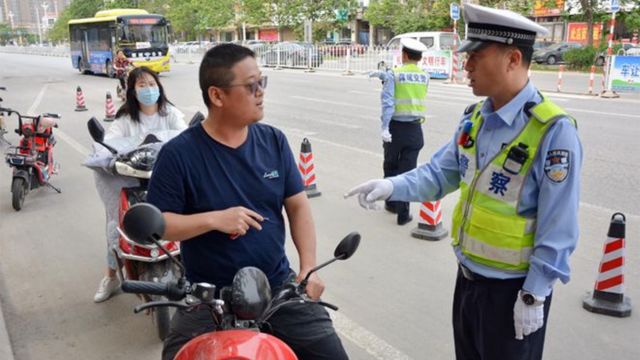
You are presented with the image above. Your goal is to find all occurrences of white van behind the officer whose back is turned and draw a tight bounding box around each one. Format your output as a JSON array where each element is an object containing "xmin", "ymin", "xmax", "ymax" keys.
[{"xmin": 378, "ymin": 31, "xmax": 454, "ymax": 79}]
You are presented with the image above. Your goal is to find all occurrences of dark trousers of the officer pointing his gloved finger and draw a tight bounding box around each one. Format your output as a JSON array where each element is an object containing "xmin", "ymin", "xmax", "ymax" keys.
[{"xmin": 453, "ymin": 270, "xmax": 551, "ymax": 360}]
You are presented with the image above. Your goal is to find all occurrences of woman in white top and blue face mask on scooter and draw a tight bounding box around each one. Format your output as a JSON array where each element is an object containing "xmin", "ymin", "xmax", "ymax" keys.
[{"xmin": 93, "ymin": 67, "xmax": 187, "ymax": 302}]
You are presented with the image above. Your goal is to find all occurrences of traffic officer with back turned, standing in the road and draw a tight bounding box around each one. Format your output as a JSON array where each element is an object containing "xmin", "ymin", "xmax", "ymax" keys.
[{"xmin": 370, "ymin": 38, "xmax": 429, "ymax": 225}]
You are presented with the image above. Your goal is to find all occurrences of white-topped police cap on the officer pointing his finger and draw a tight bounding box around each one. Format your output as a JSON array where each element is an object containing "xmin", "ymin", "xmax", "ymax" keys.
[{"xmin": 458, "ymin": 4, "xmax": 549, "ymax": 52}]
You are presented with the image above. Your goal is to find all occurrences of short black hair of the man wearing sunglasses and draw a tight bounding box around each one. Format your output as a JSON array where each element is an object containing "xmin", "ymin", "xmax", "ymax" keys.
[{"xmin": 200, "ymin": 44, "xmax": 256, "ymax": 108}]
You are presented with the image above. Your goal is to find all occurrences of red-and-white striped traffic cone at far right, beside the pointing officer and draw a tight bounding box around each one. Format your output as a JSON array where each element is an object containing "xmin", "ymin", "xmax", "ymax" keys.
[{"xmin": 582, "ymin": 213, "xmax": 631, "ymax": 317}]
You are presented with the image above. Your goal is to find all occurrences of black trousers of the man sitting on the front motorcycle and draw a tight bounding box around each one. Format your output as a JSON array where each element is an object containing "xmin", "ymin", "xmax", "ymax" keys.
[{"xmin": 162, "ymin": 276, "xmax": 349, "ymax": 360}]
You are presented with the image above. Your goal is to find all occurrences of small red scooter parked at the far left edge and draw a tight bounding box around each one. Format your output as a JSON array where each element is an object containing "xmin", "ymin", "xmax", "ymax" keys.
[{"xmin": 0, "ymin": 95, "xmax": 62, "ymax": 211}]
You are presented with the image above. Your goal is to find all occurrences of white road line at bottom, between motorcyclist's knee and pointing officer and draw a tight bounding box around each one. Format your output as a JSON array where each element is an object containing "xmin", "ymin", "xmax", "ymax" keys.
[{"xmin": 331, "ymin": 311, "xmax": 411, "ymax": 360}]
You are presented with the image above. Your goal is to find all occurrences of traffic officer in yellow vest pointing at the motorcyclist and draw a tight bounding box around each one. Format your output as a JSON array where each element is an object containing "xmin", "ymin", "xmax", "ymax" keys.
[{"xmin": 345, "ymin": 4, "xmax": 582, "ymax": 360}]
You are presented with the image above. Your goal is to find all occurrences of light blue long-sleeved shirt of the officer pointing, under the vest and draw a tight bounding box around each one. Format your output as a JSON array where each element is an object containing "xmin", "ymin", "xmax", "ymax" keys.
[{"xmin": 390, "ymin": 82, "xmax": 582, "ymax": 296}]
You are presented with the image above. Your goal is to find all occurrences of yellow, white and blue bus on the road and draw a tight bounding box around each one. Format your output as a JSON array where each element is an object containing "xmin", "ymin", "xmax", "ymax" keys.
[{"xmin": 69, "ymin": 9, "xmax": 170, "ymax": 76}]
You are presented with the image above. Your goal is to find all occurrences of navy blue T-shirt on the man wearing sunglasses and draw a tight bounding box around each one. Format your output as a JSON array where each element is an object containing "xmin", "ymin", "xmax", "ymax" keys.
[{"xmin": 147, "ymin": 124, "xmax": 304, "ymax": 287}]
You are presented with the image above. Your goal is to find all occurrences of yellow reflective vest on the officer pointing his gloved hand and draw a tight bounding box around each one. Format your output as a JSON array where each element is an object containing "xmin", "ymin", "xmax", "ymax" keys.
[{"xmin": 451, "ymin": 98, "xmax": 576, "ymax": 273}]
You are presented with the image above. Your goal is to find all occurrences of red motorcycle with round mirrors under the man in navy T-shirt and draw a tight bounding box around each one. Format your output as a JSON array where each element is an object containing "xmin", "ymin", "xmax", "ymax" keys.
[{"xmin": 122, "ymin": 204, "xmax": 360, "ymax": 360}]
